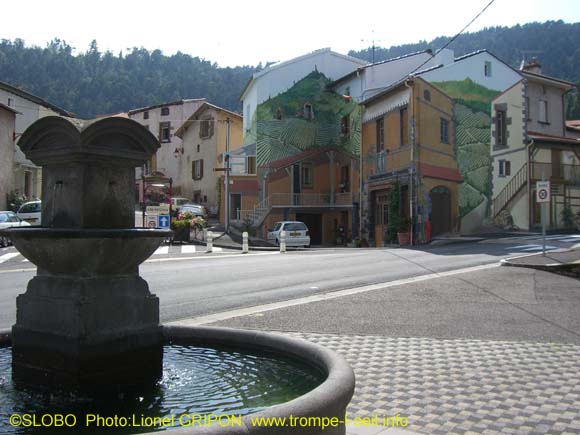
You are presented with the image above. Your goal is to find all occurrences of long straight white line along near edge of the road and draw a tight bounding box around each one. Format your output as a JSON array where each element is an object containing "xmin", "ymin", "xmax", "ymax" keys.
[{"xmin": 169, "ymin": 263, "xmax": 500, "ymax": 326}]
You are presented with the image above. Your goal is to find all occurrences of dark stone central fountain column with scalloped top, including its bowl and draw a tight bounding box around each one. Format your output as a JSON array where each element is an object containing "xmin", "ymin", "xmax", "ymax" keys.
[{"xmin": 10, "ymin": 117, "xmax": 169, "ymax": 388}]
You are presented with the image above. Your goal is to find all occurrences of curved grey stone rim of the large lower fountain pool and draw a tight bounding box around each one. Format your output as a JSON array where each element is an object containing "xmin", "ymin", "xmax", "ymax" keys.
[{"xmin": 0, "ymin": 326, "xmax": 354, "ymax": 435}]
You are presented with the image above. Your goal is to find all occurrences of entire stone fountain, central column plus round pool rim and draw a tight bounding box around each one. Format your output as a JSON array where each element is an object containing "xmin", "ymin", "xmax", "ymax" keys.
[{"xmin": 0, "ymin": 117, "xmax": 354, "ymax": 435}]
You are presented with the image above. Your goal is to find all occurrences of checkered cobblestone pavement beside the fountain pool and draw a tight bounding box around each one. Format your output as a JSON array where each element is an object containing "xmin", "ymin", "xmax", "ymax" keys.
[{"xmin": 290, "ymin": 333, "xmax": 580, "ymax": 434}]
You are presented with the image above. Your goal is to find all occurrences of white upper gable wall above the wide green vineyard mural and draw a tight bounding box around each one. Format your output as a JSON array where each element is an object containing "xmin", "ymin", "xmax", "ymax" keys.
[{"xmin": 240, "ymin": 48, "xmax": 368, "ymax": 130}]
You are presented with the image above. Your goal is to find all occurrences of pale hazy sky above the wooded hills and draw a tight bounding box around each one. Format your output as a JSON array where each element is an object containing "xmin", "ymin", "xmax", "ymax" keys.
[{"xmin": 0, "ymin": 0, "xmax": 580, "ymax": 67}]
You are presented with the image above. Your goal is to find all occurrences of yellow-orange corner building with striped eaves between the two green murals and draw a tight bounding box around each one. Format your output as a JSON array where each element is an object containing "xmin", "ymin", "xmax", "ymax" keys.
[{"xmin": 361, "ymin": 77, "xmax": 462, "ymax": 246}]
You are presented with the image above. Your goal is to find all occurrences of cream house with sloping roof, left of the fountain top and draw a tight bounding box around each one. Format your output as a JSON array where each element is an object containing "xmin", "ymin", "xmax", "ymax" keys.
[{"xmin": 0, "ymin": 82, "xmax": 74, "ymax": 199}]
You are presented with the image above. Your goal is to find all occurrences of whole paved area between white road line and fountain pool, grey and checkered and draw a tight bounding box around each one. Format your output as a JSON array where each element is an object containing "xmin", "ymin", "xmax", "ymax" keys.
[{"xmin": 208, "ymin": 268, "xmax": 580, "ymax": 435}]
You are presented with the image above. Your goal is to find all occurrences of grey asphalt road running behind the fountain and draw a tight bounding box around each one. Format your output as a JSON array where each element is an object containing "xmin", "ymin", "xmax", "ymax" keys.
[{"xmin": 0, "ymin": 238, "xmax": 580, "ymax": 328}]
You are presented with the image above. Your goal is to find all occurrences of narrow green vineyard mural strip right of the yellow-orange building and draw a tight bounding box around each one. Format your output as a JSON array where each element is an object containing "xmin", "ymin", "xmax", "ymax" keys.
[{"xmin": 434, "ymin": 79, "xmax": 499, "ymax": 225}]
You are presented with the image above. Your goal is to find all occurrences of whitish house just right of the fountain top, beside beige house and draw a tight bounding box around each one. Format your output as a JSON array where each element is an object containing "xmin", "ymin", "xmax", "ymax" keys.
[{"xmin": 128, "ymin": 98, "xmax": 205, "ymax": 195}]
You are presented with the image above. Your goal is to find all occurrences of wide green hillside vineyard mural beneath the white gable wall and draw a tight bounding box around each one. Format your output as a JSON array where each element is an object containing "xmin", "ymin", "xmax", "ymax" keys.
[{"xmin": 245, "ymin": 71, "xmax": 361, "ymax": 166}]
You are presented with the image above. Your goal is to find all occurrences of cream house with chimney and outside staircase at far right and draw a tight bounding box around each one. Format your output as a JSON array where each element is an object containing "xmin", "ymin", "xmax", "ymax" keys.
[{"xmin": 491, "ymin": 60, "xmax": 580, "ymax": 230}]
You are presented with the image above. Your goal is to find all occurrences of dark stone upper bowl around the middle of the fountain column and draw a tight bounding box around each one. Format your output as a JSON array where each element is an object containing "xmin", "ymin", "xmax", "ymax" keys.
[{"xmin": 5, "ymin": 227, "xmax": 171, "ymax": 276}]
